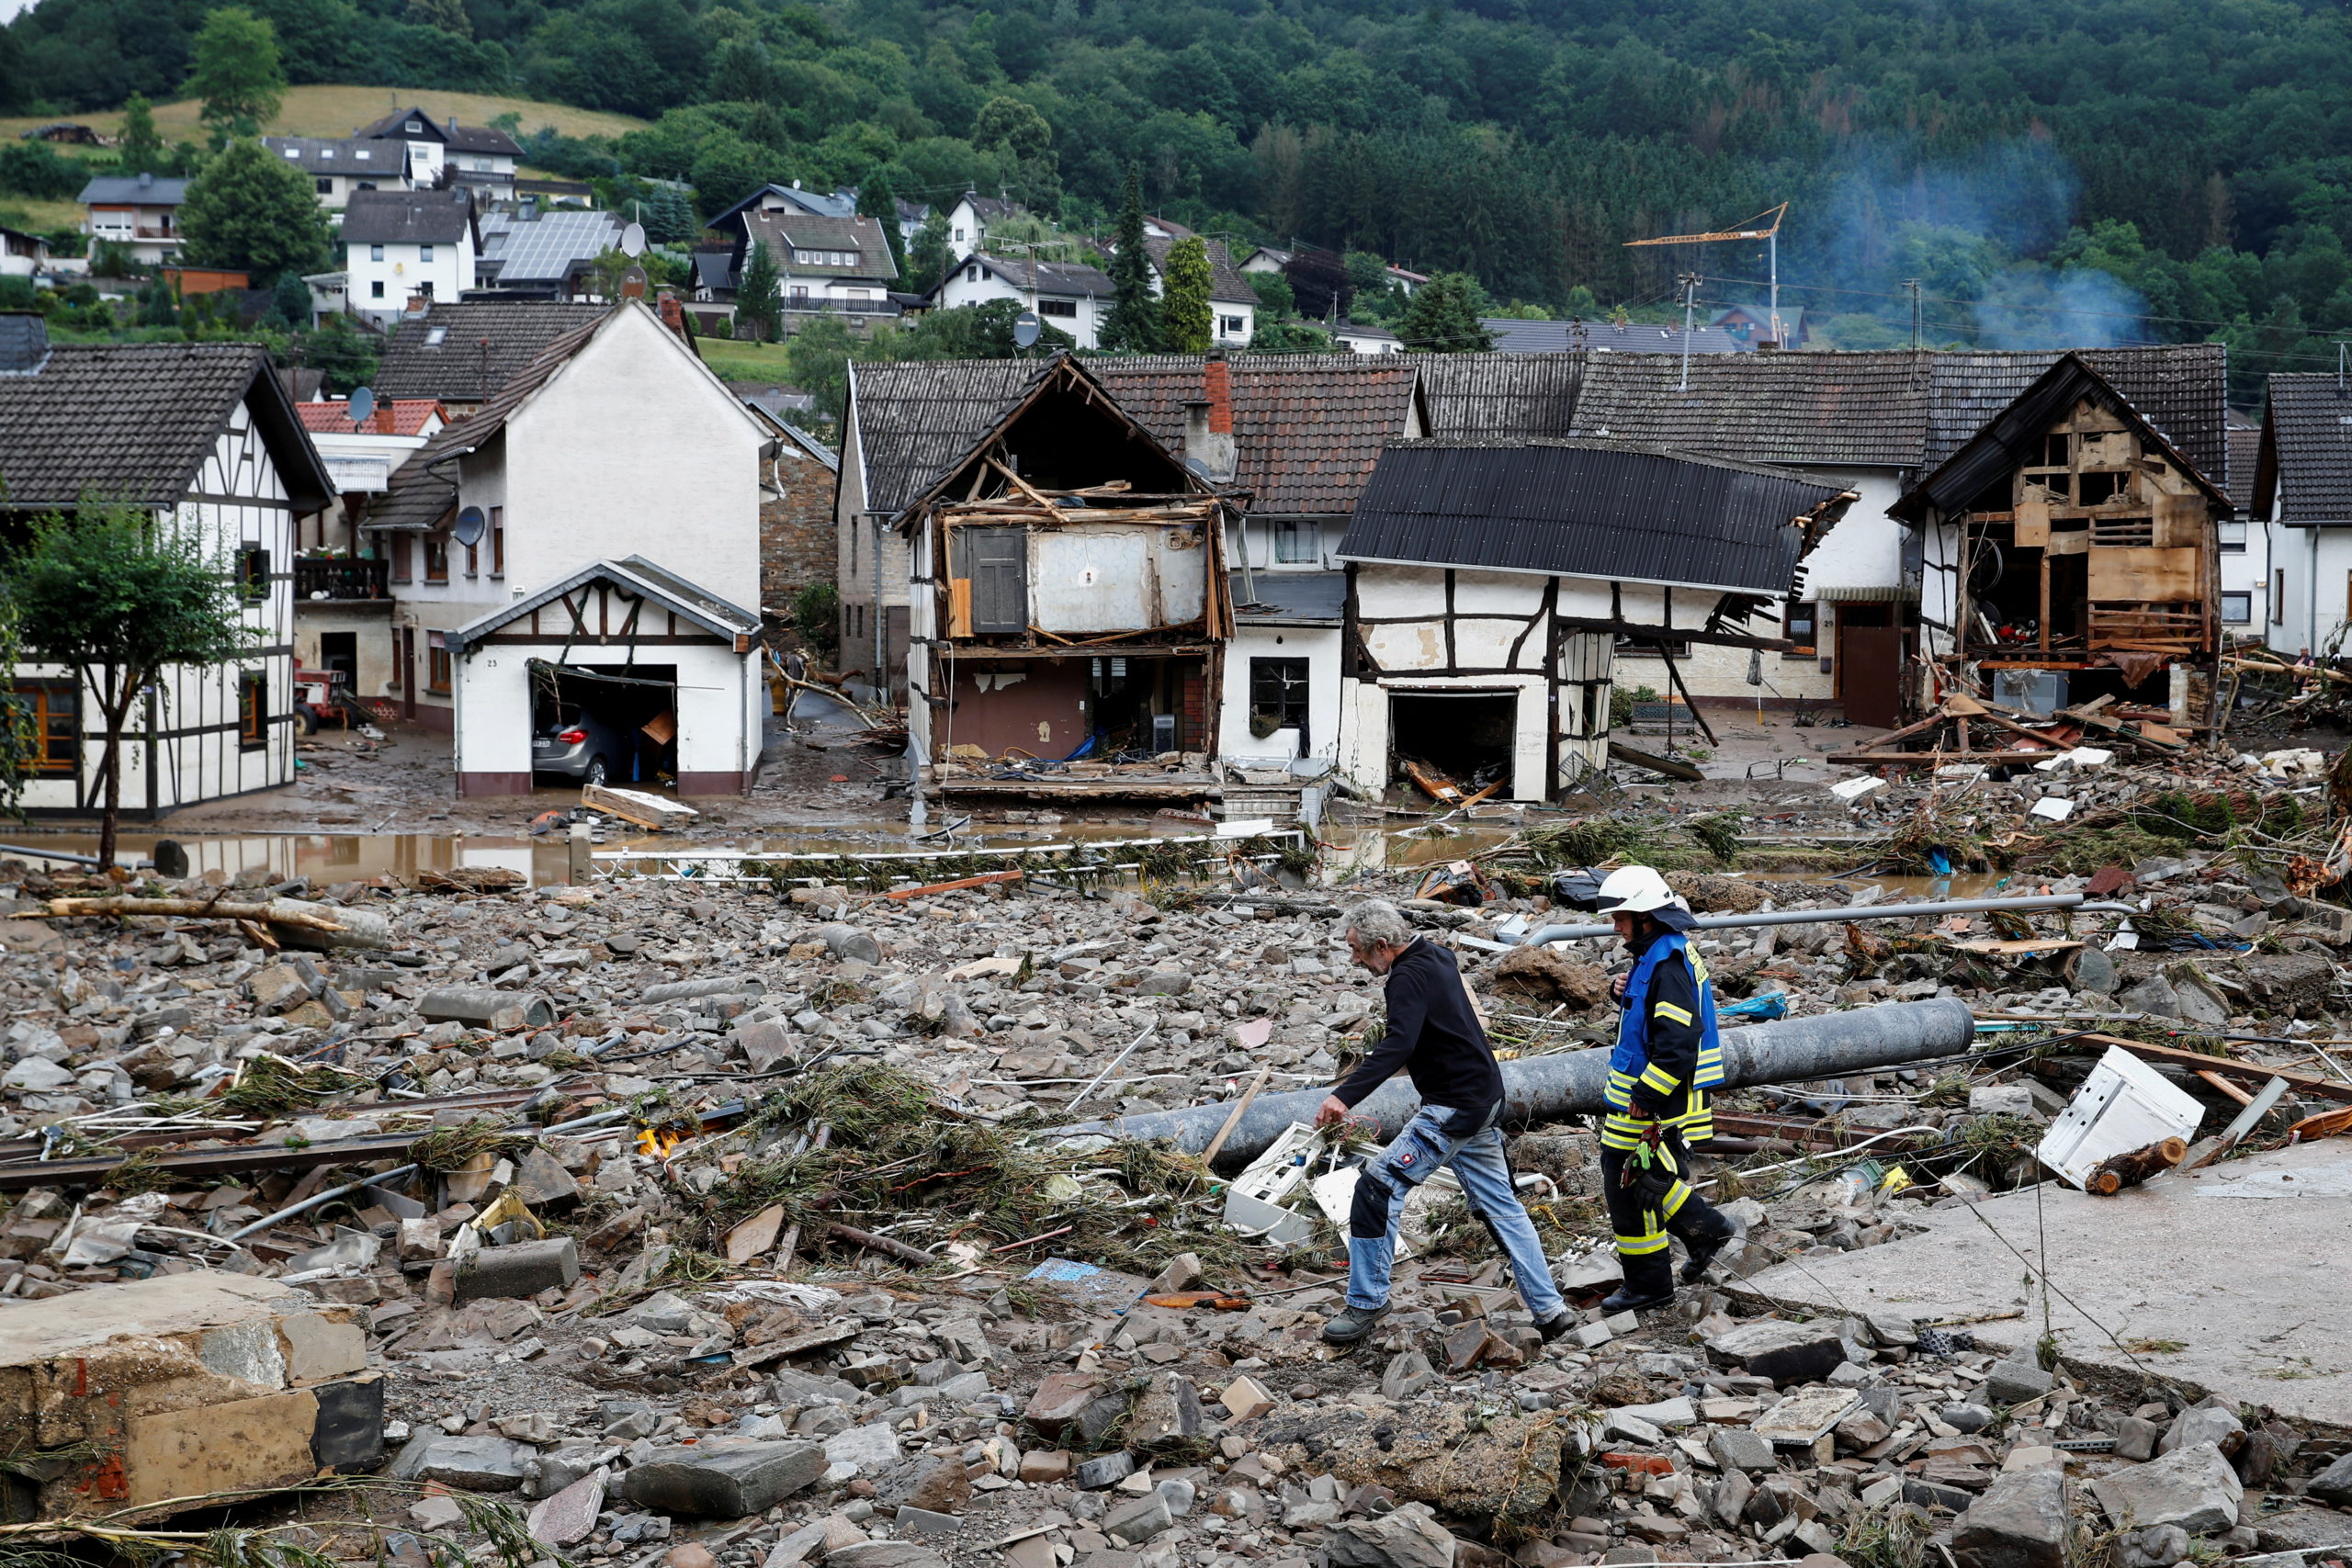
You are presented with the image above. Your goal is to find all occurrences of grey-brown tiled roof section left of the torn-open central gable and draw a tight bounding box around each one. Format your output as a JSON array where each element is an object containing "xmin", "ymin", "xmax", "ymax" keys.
[{"xmin": 849, "ymin": 360, "xmax": 1054, "ymax": 513}]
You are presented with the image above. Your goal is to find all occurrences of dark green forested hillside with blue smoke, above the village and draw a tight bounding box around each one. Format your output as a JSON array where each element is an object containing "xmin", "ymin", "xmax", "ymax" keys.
[{"xmin": 0, "ymin": 0, "xmax": 2352, "ymax": 380}]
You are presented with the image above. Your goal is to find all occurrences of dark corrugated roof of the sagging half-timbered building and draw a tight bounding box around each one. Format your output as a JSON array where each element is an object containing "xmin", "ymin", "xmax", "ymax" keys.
[{"xmin": 1339, "ymin": 440, "xmax": 1847, "ymax": 597}]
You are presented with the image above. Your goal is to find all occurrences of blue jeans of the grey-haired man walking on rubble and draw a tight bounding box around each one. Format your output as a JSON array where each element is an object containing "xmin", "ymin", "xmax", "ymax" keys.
[{"xmin": 1348, "ymin": 1100, "xmax": 1566, "ymax": 1319}]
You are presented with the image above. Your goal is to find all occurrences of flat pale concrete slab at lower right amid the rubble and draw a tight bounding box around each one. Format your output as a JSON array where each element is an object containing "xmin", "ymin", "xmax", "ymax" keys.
[{"xmin": 1734, "ymin": 1138, "xmax": 2352, "ymax": 1427}]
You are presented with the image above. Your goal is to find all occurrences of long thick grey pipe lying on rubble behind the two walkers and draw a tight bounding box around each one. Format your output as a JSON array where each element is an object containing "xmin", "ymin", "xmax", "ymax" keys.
[{"xmin": 1049, "ymin": 997, "xmax": 1975, "ymax": 1170}]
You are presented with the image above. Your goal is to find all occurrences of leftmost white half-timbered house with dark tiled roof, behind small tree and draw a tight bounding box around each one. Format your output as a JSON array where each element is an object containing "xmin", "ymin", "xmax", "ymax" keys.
[{"xmin": 0, "ymin": 331, "xmax": 332, "ymax": 816}]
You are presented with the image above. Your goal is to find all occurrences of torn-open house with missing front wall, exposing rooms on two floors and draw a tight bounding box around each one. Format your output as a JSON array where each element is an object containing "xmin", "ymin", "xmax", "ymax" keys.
[{"xmin": 896, "ymin": 355, "xmax": 1232, "ymax": 799}]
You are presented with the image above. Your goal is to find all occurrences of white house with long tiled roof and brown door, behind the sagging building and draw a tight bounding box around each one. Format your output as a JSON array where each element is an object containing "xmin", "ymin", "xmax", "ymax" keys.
[{"xmin": 1561, "ymin": 344, "xmax": 2230, "ymax": 724}]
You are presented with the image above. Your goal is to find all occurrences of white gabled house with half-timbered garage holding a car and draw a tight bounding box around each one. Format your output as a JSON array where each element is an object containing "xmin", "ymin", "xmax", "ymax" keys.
[{"xmin": 362, "ymin": 301, "xmax": 772, "ymax": 795}]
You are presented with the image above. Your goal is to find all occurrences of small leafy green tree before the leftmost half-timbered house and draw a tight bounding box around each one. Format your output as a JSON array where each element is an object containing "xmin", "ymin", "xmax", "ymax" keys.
[{"xmin": 5, "ymin": 505, "xmax": 254, "ymax": 865}]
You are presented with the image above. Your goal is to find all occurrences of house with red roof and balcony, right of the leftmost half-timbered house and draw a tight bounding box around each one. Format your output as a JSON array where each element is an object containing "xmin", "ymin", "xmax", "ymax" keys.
[{"xmin": 291, "ymin": 398, "xmax": 449, "ymax": 694}]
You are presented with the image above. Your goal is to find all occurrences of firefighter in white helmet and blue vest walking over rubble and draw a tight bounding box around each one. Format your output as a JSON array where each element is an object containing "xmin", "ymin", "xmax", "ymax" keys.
[{"xmin": 1600, "ymin": 865, "xmax": 1734, "ymax": 1312}]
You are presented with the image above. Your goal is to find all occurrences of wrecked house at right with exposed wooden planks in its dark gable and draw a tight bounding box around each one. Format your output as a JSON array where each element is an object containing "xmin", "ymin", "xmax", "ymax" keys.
[{"xmin": 1891, "ymin": 355, "xmax": 2232, "ymax": 724}]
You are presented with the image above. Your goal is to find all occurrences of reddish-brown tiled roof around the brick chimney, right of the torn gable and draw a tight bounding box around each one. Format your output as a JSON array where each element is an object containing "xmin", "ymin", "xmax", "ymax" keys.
[{"xmin": 1087, "ymin": 355, "xmax": 1419, "ymax": 517}]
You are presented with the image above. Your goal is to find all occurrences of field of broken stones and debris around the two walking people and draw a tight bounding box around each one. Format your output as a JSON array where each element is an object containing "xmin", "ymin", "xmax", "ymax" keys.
[{"xmin": 0, "ymin": 752, "xmax": 2352, "ymax": 1568}]
